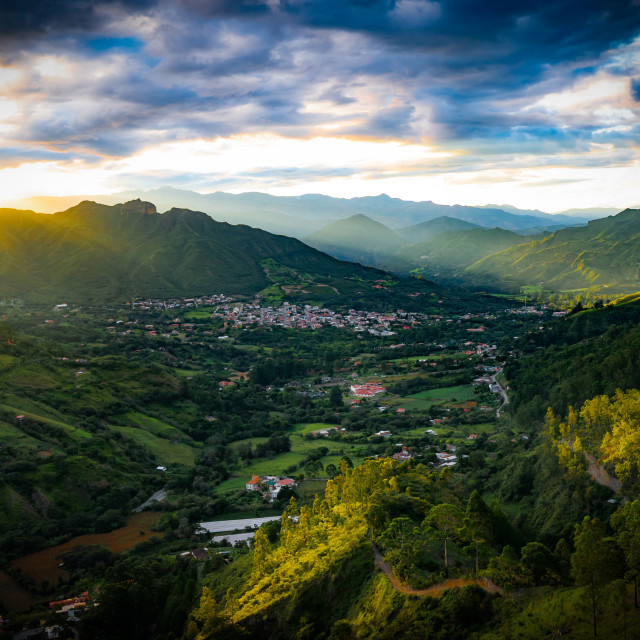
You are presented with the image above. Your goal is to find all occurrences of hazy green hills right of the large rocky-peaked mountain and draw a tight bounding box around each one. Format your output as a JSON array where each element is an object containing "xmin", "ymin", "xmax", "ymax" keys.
[{"xmin": 305, "ymin": 209, "xmax": 640, "ymax": 292}]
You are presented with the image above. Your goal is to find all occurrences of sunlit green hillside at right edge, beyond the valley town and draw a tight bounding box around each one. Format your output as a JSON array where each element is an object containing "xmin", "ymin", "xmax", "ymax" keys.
[{"xmin": 466, "ymin": 209, "xmax": 640, "ymax": 290}]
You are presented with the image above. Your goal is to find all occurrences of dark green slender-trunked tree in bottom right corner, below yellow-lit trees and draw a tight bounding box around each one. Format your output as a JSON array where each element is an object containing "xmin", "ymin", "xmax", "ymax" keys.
[{"xmin": 571, "ymin": 516, "xmax": 621, "ymax": 636}]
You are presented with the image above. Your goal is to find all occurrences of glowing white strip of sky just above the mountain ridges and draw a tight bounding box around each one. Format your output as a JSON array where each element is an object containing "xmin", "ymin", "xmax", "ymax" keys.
[{"xmin": 0, "ymin": 134, "xmax": 640, "ymax": 212}]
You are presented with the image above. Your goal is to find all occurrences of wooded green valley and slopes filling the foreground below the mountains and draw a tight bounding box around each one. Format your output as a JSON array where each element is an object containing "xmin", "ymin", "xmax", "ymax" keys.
[{"xmin": 0, "ymin": 298, "xmax": 640, "ymax": 640}]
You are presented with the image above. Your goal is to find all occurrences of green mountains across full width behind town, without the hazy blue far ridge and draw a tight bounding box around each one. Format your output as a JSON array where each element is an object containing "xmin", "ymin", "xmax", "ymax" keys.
[{"xmin": 0, "ymin": 196, "xmax": 640, "ymax": 303}]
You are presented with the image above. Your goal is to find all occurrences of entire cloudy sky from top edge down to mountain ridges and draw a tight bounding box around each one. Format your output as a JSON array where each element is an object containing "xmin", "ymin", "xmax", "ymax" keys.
[{"xmin": 0, "ymin": 0, "xmax": 640, "ymax": 211}]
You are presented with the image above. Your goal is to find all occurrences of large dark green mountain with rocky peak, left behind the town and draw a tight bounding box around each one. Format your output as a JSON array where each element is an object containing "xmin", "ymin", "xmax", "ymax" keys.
[{"xmin": 0, "ymin": 201, "xmax": 388, "ymax": 302}]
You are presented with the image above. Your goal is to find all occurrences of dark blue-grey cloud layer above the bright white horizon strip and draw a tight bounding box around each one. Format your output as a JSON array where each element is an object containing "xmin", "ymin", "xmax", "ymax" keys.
[{"xmin": 0, "ymin": 0, "xmax": 640, "ymax": 165}]
